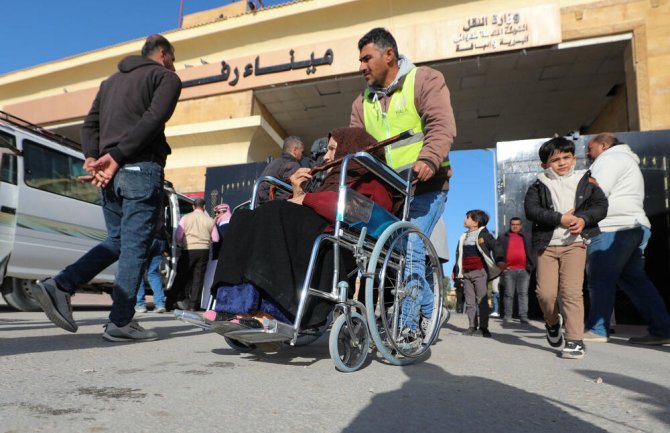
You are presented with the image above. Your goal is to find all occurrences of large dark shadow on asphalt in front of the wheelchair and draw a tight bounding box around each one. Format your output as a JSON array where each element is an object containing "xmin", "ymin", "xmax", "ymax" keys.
[{"xmin": 343, "ymin": 363, "xmax": 616, "ymax": 433}]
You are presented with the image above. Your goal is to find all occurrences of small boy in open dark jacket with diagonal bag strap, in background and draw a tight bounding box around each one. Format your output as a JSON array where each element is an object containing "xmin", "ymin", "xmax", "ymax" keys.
[{"xmin": 454, "ymin": 209, "xmax": 500, "ymax": 337}]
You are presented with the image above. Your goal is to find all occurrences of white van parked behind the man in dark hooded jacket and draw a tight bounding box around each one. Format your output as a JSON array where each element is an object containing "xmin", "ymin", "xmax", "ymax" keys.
[{"xmin": 0, "ymin": 111, "xmax": 192, "ymax": 311}]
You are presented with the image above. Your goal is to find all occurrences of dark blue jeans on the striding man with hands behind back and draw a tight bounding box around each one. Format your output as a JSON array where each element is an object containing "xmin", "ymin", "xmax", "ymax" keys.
[{"xmin": 54, "ymin": 162, "xmax": 163, "ymax": 326}]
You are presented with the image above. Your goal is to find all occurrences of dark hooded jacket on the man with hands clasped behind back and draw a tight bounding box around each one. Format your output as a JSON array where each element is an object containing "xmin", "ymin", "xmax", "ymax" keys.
[{"xmin": 81, "ymin": 56, "xmax": 181, "ymax": 166}]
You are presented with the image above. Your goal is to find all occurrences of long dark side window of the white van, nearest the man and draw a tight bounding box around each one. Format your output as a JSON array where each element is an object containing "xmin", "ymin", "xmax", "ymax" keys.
[{"xmin": 23, "ymin": 140, "xmax": 100, "ymax": 205}]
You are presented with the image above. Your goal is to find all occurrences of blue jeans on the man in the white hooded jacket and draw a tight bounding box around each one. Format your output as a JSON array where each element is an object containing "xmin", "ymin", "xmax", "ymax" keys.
[{"xmin": 586, "ymin": 226, "xmax": 670, "ymax": 337}]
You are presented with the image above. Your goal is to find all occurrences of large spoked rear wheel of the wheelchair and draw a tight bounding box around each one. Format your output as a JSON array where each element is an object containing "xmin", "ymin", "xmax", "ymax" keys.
[{"xmin": 365, "ymin": 221, "xmax": 443, "ymax": 365}]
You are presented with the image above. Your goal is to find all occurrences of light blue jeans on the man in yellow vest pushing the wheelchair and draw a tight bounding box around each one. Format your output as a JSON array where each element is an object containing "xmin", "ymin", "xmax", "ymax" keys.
[{"xmin": 400, "ymin": 191, "xmax": 447, "ymax": 331}]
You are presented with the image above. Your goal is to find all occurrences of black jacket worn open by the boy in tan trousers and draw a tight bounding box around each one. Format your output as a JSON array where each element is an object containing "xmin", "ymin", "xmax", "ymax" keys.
[{"xmin": 524, "ymin": 171, "xmax": 607, "ymax": 253}]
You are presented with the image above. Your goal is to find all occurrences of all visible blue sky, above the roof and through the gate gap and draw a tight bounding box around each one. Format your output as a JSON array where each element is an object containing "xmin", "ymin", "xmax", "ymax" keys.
[{"xmin": 0, "ymin": 0, "xmax": 495, "ymax": 275}]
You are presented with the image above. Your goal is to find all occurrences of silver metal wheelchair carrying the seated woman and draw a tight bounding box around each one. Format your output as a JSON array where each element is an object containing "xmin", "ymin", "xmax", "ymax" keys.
[{"xmin": 181, "ymin": 148, "xmax": 447, "ymax": 372}]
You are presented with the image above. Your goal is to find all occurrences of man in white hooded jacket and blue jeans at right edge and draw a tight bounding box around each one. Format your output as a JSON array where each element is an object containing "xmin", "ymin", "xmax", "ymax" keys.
[{"xmin": 584, "ymin": 132, "xmax": 670, "ymax": 345}]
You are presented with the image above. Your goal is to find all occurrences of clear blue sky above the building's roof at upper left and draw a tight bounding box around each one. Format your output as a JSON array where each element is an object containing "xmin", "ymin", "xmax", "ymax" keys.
[{"xmin": 0, "ymin": 0, "xmax": 288, "ymax": 75}]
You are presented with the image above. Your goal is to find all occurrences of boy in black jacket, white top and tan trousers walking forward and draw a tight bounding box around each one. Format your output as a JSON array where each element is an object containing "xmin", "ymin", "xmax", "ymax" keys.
[{"xmin": 524, "ymin": 137, "xmax": 607, "ymax": 359}]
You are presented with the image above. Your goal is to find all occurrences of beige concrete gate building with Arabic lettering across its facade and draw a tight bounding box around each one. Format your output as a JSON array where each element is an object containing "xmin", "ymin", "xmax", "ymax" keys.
[{"xmin": 0, "ymin": 0, "xmax": 670, "ymax": 193}]
